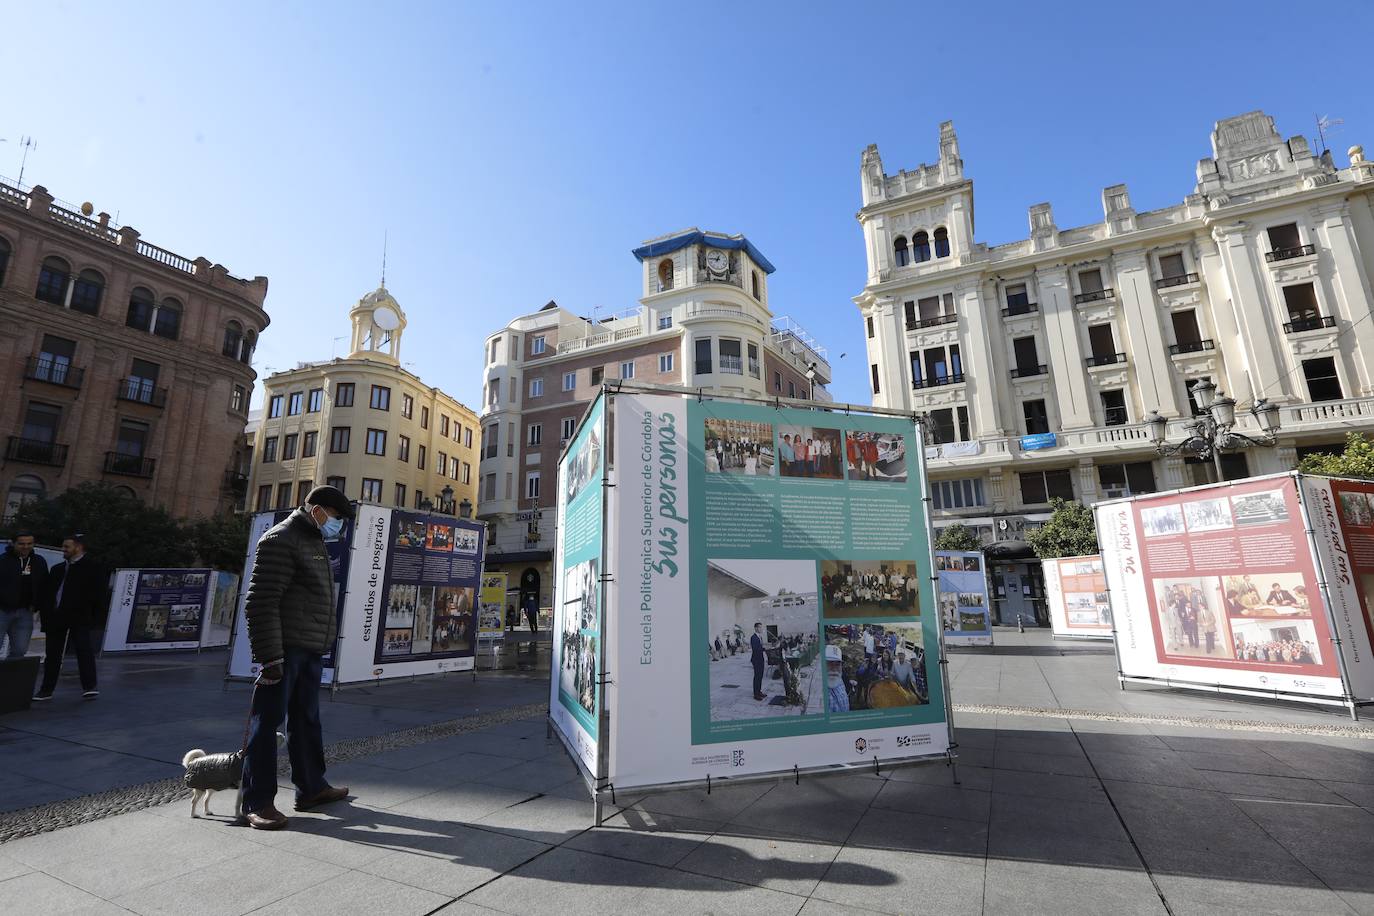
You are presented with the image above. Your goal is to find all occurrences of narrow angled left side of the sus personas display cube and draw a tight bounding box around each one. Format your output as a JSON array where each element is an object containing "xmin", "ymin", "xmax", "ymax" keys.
[{"xmin": 548, "ymin": 397, "xmax": 604, "ymax": 780}]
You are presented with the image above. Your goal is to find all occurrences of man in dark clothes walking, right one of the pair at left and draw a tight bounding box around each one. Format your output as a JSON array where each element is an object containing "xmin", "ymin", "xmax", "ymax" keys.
[{"xmin": 33, "ymin": 534, "xmax": 110, "ymax": 700}]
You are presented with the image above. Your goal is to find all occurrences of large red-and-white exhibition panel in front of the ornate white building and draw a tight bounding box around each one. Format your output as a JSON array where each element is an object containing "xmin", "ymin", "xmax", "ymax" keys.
[{"xmin": 1096, "ymin": 475, "xmax": 1374, "ymax": 695}]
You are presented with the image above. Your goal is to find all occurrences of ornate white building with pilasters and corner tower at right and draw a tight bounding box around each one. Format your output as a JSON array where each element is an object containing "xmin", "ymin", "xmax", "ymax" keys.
[{"xmin": 855, "ymin": 111, "xmax": 1374, "ymax": 621}]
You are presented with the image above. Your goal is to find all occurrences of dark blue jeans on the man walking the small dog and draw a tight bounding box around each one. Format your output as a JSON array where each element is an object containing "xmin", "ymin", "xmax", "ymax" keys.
[{"xmin": 243, "ymin": 645, "xmax": 328, "ymax": 813}]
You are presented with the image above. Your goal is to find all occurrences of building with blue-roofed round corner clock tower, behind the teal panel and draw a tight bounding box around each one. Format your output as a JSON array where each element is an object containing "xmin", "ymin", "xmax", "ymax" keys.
[{"xmin": 478, "ymin": 229, "xmax": 830, "ymax": 623}]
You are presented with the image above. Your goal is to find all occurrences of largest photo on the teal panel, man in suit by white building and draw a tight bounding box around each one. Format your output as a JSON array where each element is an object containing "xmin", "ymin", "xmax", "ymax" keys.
[{"xmin": 706, "ymin": 559, "xmax": 826, "ymax": 722}]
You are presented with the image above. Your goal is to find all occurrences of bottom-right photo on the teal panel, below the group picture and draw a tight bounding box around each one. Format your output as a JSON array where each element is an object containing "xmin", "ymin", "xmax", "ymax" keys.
[{"xmin": 826, "ymin": 623, "xmax": 930, "ymax": 713}]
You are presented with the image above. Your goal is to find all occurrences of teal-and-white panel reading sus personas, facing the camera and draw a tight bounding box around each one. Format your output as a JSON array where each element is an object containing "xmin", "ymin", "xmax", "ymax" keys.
[{"xmin": 609, "ymin": 393, "xmax": 948, "ymax": 787}]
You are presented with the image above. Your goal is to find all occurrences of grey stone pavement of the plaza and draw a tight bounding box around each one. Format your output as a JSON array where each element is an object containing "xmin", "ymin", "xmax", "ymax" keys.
[{"xmin": 0, "ymin": 630, "xmax": 1374, "ymax": 916}]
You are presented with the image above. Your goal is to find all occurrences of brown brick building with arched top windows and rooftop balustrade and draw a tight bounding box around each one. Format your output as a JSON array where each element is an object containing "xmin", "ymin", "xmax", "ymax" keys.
[{"xmin": 0, "ymin": 184, "xmax": 268, "ymax": 518}]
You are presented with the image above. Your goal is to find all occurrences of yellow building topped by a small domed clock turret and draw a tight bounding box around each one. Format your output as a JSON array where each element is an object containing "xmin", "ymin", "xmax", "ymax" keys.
[{"xmin": 247, "ymin": 287, "xmax": 478, "ymax": 515}]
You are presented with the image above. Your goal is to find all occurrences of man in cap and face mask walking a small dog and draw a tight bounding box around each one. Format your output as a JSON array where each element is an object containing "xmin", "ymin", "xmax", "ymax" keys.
[{"xmin": 243, "ymin": 486, "xmax": 353, "ymax": 829}]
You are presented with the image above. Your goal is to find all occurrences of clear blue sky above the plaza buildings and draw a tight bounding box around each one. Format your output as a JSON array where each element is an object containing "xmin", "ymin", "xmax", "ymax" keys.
[{"xmin": 0, "ymin": 3, "xmax": 1374, "ymax": 405}]
